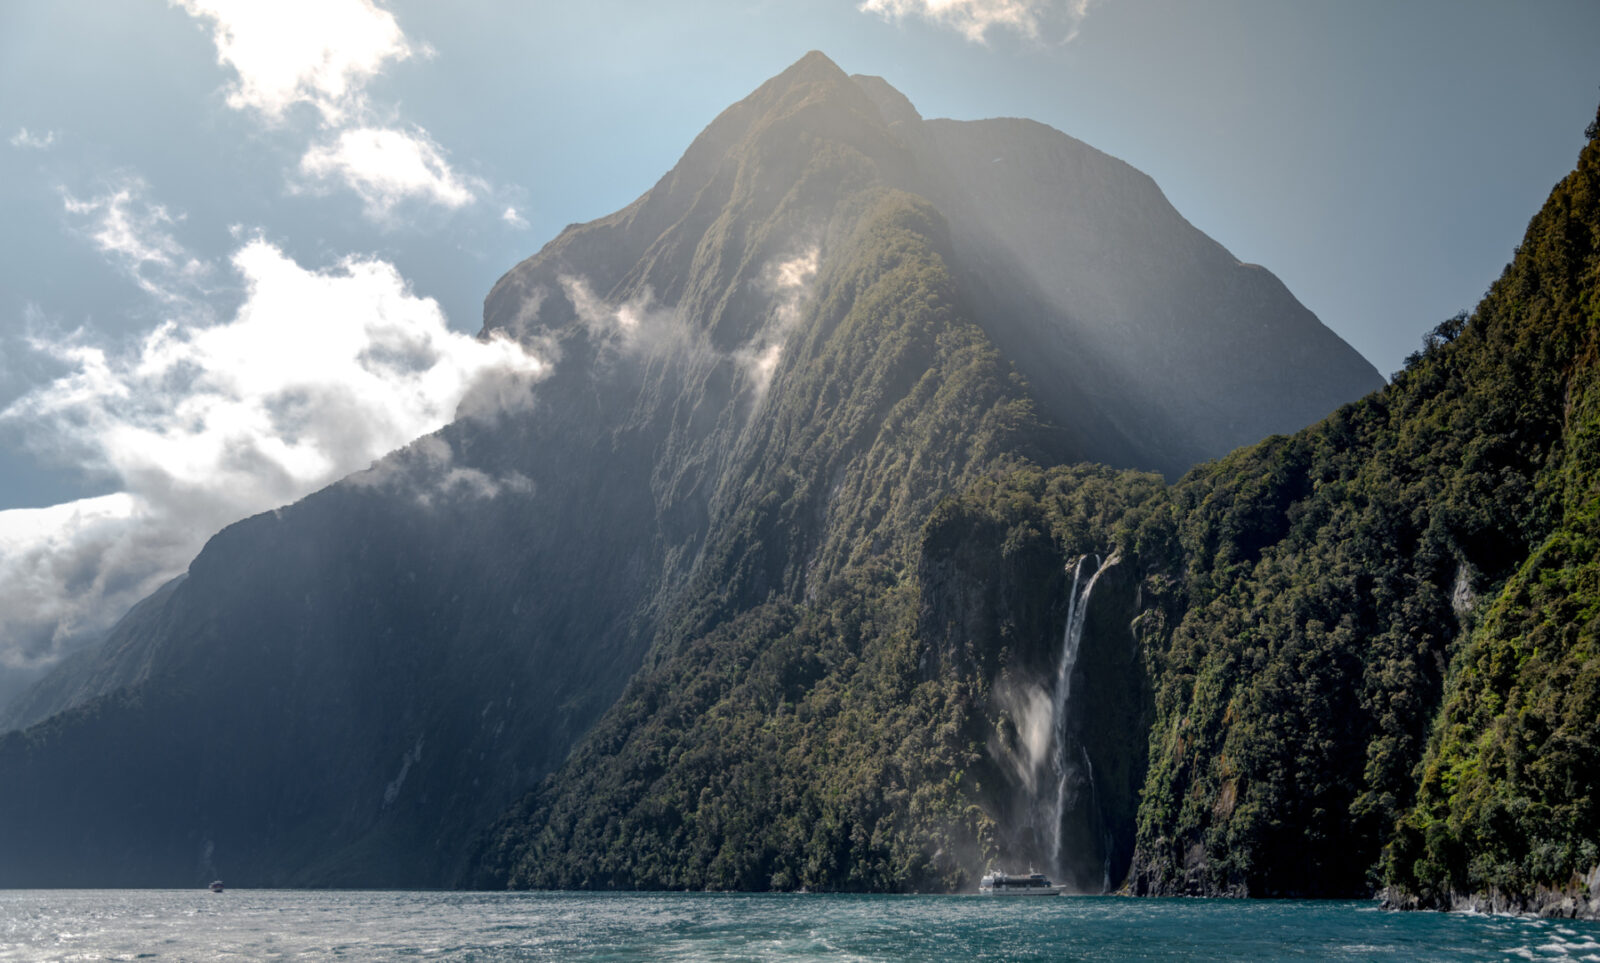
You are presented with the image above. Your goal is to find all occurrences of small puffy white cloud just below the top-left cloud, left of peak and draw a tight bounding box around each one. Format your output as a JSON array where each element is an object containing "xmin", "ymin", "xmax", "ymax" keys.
[{"xmin": 301, "ymin": 126, "xmax": 477, "ymax": 221}]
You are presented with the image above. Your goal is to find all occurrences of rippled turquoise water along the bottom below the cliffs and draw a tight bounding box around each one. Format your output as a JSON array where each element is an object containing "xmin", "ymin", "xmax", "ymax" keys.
[{"xmin": 0, "ymin": 889, "xmax": 1600, "ymax": 963}]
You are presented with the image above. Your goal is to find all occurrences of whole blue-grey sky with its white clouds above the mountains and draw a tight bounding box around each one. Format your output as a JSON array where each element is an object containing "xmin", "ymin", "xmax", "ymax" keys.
[{"xmin": 0, "ymin": 0, "xmax": 1600, "ymax": 699}]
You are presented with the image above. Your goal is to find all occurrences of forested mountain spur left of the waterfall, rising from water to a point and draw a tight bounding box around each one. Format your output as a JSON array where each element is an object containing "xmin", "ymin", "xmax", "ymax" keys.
[{"xmin": 480, "ymin": 183, "xmax": 1158, "ymax": 891}]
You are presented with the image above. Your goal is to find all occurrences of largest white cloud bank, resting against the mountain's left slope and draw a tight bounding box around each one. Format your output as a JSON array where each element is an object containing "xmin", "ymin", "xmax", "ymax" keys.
[{"xmin": 0, "ymin": 238, "xmax": 544, "ymax": 667}]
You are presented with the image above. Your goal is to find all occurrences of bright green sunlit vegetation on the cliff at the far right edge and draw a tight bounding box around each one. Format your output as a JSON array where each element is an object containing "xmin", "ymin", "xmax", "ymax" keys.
[{"xmin": 1389, "ymin": 118, "xmax": 1600, "ymax": 909}]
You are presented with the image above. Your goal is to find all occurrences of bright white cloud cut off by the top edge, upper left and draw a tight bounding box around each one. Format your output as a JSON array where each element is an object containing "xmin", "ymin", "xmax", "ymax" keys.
[{"xmin": 171, "ymin": 0, "xmax": 424, "ymax": 125}]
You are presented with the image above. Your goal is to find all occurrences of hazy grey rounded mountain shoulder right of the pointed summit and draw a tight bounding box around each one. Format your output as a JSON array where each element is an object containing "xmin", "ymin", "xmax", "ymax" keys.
[{"xmin": 854, "ymin": 77, "xmax": 1382, "ymax": 478}]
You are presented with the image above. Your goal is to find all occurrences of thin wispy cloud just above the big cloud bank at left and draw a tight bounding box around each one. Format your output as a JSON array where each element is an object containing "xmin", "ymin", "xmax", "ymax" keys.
[{"xmin": 62, "ymin": 178, "xmax": 210, "ymax": 302}]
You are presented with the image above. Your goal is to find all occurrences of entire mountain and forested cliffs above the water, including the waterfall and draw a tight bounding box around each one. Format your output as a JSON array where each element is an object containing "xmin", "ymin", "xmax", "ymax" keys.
[{"xmin": 0, "ymin": 54, "xmax": 1600, "ymax": 912}]
